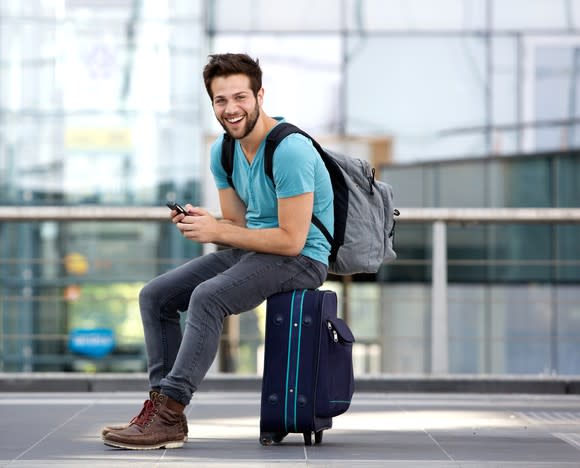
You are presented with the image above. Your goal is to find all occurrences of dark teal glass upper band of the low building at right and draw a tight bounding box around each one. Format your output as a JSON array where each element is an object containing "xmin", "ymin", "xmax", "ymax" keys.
[{"xmin": 383, "ymin": 151, "xmax": 580, "ymax": 284}]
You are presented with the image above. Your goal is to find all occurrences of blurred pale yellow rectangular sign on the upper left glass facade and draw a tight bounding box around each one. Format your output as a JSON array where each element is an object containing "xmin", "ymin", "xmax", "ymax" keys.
[{"xmin": 64, "ymin": 128, "xmax": 132, "ymax": 151}]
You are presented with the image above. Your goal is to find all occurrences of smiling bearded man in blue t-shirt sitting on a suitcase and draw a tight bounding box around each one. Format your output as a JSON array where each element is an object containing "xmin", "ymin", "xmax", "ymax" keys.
[{"xmin": 103, "ymin": 54, "xmax": 334, "ymax": 449}]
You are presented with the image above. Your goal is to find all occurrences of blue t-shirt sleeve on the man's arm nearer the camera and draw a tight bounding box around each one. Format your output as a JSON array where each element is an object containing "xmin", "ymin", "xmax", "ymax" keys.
[{"xmin": 273, "ymin": 134, "xmax": 320, "ymax": 198}]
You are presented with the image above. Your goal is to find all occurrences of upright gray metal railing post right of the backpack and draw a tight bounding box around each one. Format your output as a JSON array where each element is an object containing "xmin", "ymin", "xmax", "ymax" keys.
[{"xmin": 431, "ymin": 221, "xmax": 449, "ymax": 374}]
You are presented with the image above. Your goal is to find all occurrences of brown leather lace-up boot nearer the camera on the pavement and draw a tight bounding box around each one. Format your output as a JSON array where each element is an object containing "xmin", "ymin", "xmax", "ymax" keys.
[{"xmin": 103, "ymin": 393, "xmax": 185, "ymax": 450}]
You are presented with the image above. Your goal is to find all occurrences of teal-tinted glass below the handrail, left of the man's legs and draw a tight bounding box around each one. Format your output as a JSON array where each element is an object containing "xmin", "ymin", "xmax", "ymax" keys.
[{"xmin": 0, "ymin": 218, "xmax": 200, "ymax": 371}]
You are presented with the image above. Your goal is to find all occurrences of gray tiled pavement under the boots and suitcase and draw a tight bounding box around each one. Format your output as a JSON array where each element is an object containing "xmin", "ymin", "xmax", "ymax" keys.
[{"xmin": 0, "ymin": 392, "xmax": 580, "ymax": 468}]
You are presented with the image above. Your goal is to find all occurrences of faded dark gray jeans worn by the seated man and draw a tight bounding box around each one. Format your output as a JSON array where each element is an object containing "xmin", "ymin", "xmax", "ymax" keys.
[{"xmin": 139, "ymin": 249, "xmax": 327, "ymax": 405}]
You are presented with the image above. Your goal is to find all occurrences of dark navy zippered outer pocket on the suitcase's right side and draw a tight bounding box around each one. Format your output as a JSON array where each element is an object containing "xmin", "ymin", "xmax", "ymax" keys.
[{"xmin": 316, "ymin": 317, "xmax": 354, "ymax": 418}]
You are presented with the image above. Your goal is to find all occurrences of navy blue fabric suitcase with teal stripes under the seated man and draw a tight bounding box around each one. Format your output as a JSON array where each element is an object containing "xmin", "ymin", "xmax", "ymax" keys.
[{"xmin": 260, "ymin": 290, "xmax": 354, "ymax": 445}]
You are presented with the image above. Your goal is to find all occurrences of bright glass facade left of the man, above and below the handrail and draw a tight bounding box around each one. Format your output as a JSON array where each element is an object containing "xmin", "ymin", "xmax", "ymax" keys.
[{"xmin": 0, "ymin": 0, "xmax": 205, "ymax": 371}]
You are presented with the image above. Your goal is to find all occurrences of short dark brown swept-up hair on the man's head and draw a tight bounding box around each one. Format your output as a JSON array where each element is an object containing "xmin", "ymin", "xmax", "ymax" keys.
[{"xmin": 203, "ymin": 53, "xmax": 262, "ymax": 100}]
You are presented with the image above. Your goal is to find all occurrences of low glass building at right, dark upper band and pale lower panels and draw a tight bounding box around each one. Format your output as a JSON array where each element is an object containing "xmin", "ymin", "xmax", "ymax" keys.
[{"xmin": 378, "ymin": 151, "xmax": 580, "ymax": 374}]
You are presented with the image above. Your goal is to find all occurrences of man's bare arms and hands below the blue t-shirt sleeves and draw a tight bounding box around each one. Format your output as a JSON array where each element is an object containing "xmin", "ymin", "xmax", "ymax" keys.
[{"xmin": 174, "ymin": 188, "xmax": 314, "ymax": 256}]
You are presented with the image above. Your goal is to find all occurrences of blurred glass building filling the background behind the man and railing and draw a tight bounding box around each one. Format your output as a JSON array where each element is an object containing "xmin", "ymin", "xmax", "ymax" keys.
[{"xmin": 0, "ymin": 0, "xmax": 580, "ymax": 374}]
